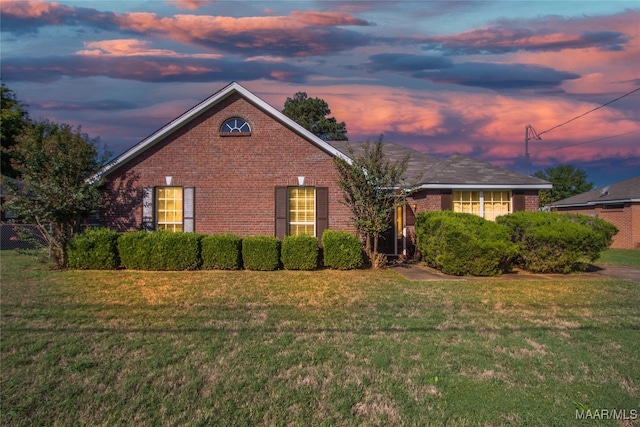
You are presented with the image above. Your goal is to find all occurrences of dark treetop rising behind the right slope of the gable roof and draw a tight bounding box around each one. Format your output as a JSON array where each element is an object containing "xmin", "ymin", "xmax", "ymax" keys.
[{"xmin": 282, "ymin": 92, "xmax": 347, "ymax": 141}]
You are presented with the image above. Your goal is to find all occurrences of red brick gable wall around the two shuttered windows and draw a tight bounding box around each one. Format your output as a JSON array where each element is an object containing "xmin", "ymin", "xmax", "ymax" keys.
[{"xmin": 102, "ymin": 94, "xmax": 352, "ymax": 236}]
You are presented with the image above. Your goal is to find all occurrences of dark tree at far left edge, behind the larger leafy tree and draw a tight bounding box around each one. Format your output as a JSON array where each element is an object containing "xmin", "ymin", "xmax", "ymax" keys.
[{"xmin": 0, "ymin": 83, "xmax": 31, "ymax": 178}]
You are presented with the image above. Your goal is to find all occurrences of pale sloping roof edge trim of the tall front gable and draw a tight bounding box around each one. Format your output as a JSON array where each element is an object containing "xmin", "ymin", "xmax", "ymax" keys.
[{"xmin": 97, "ymin": 82, "xmax": 351, "ymax": 176}]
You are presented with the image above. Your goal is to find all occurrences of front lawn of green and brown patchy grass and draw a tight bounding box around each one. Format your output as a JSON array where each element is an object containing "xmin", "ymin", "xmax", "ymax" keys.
[{"xmin": 0, "ymin": 251, "xmax": 640, "ymax": 426}]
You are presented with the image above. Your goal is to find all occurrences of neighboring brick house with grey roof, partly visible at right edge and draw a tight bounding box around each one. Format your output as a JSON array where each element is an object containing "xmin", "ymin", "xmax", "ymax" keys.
[{"xmin": 549, "ymin": 175, "xmax": 640, "ymax": 249}]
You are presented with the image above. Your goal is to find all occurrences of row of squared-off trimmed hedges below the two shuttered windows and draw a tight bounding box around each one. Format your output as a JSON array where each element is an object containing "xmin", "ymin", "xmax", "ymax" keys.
[{"xmin": 68, "ymin": 228, "xmax": 364, "ymax": 271}]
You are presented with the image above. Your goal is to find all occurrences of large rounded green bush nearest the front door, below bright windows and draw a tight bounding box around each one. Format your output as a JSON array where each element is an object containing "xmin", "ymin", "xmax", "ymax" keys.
[{"xmin": 416, "ymin": 211, "xmax": 517, "ymax": 276}]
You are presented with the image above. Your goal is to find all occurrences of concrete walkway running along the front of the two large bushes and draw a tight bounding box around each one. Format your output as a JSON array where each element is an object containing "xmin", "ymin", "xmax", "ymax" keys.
[{"xmin": 392, "ymin": 263, "xmax": 640, "ymax": 283}]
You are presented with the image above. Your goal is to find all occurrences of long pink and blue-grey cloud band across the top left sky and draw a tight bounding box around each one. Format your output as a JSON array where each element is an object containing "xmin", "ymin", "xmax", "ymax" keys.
[{"xmin": 3, "ymin": 0, "xmax": 371, "ymax": 56}]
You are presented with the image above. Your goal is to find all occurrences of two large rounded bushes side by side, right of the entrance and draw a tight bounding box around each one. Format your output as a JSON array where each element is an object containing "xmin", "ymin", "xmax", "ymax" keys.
[{"xmin": 416, "ymin": 211, "xmax": 618, "ymax": 276}]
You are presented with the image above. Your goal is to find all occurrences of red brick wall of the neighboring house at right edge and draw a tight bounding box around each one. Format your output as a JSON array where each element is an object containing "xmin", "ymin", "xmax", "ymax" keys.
[{"xmin": 558, "ymin": 203, "xmax": 640, "ymax": 249}]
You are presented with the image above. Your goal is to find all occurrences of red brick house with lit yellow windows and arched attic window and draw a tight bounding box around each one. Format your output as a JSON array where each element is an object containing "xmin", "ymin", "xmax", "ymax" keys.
[{"xmin": 101, "ymin": 82, "xmax": 551, "ymax": 254}]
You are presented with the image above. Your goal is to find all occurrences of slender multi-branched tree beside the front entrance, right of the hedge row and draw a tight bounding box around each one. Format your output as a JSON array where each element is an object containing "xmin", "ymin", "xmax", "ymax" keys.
[{"xmin": 335, "ymin": 135, "xmax": 410, "ymax": 268}]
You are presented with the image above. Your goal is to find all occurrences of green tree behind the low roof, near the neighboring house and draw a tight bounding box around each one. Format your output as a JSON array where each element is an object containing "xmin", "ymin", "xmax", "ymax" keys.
[{"xmin": 533, "ymin": 165, "xmax": 593, "ymax": 206}]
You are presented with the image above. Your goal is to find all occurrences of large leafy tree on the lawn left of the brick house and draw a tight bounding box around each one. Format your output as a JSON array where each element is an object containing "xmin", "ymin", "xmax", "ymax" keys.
[{"xmin": 3, "ymin": 121, "xmax": 109, "ymax": 267}]
